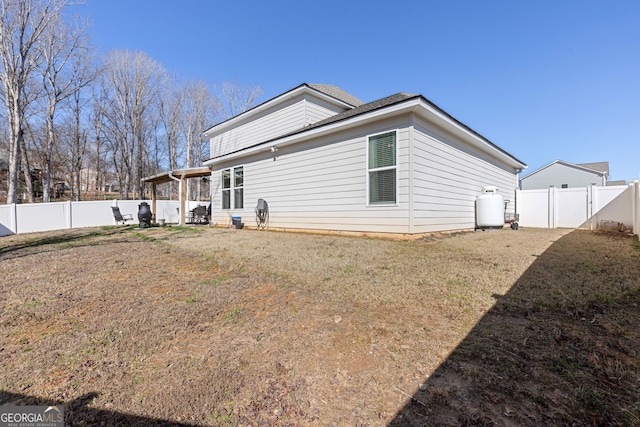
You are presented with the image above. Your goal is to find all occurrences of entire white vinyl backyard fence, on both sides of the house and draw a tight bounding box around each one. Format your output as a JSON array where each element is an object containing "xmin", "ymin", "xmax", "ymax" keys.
[{"xmin": 0, "ymin": 181, "xmax": 640, "ymax": 237}]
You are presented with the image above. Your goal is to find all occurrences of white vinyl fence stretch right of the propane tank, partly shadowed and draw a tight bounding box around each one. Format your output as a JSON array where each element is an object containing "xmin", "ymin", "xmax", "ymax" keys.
[{"xmin": 516, "ymin": 181, "xmax": 640, "ymax": 234}]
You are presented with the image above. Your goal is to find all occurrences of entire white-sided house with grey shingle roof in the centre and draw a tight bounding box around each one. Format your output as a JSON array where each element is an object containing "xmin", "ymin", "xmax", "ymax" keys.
[{"xmin": 204, "ymin": 84, "xmax": 526, "ymax": 234}]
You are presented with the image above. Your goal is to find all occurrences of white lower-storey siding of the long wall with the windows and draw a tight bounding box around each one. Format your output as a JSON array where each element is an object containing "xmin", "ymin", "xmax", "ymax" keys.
[{"xmin": 212, "ymin": 118, "xmax": 409, "ymax": 233}]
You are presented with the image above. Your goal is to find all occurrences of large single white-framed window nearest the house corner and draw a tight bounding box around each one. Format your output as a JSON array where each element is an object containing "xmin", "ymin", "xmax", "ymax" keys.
[{"xmin": 367, "ymin": 130, "xmax": 398, "ymax": 205}]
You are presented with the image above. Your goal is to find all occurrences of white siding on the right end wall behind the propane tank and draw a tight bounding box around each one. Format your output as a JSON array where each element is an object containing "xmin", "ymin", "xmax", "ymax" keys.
[{"xmin": 413, "ymin": 118, "xmax": 517, "ymax": 233}]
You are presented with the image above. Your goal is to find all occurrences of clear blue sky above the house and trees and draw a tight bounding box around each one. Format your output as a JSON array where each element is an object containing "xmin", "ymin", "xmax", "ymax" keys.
[{"xmin": 75, "ymin": 0, "xmax": 640, "ymax": 180}]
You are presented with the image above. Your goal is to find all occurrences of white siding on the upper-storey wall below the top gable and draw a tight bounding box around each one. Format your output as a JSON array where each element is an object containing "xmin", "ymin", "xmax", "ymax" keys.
[{"xmin": 210, "ymin": 95, "xmax": 344, "ymax": 157}]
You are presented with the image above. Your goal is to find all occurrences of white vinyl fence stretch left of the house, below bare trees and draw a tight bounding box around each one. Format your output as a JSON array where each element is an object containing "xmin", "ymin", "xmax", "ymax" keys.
[{"xmin": 0, "ymin": 200, "xmax": 192, "ymax": 236}]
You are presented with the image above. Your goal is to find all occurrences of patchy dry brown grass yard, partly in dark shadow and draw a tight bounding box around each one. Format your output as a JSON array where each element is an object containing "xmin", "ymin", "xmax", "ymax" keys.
[{"xmin": 0, "ymin": 227, "xmax": 640, "ymax": 426}]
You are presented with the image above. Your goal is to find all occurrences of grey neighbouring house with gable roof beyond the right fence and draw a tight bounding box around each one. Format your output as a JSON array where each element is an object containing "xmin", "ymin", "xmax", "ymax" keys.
[{"xmin": 520, "ymin": 160, "xmax": 609, "ymax": 190}]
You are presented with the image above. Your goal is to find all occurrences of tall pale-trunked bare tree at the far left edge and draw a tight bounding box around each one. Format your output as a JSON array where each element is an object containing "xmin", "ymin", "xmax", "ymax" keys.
[{"xmin": 0, "ymin": 0, "xmax": 67, "ymax": 203}]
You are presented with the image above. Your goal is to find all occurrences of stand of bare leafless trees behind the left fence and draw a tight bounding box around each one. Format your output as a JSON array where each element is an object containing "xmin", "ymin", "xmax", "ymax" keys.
[{"xmin": 0, "ymin": 0, "xmax": 262, "ymax": 203}]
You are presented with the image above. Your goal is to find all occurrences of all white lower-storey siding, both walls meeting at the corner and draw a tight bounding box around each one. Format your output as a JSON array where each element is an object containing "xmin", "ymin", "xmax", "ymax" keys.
[{"xmin": 212, "ymin": 108, "xmax": 517, "ymax": 237}]
